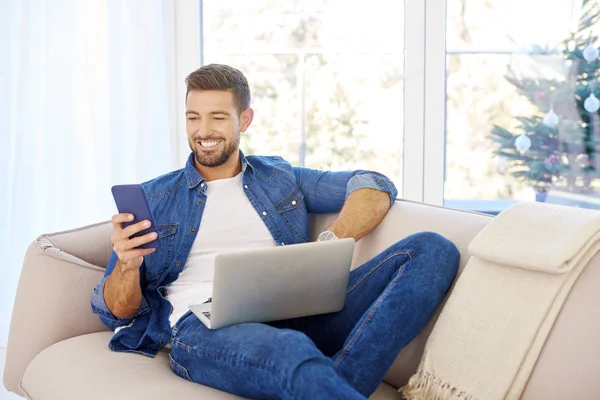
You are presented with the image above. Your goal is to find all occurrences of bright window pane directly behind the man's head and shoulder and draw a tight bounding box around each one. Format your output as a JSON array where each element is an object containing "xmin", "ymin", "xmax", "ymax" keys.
[{"xmin": 201, "ymin": 0, "xmax": 405, "ymax": 191}]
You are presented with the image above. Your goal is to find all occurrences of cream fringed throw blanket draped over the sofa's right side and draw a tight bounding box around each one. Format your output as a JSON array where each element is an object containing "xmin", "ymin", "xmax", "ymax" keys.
[{"xmin": 400, "ymin": 203, "xmax": 600, "ymax": 400}]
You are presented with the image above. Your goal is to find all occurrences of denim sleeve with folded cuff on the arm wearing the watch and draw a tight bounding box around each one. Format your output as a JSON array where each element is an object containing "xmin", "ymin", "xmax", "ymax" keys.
[{"xmin": 294, "ymin": 167, "xmax": 398, "ymax": 214}]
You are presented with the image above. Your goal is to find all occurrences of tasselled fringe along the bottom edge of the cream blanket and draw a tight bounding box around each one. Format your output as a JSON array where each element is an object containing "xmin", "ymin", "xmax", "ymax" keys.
[{"xmin": 398, "ymin": 371, "xmax": 475, "ymax": 400}]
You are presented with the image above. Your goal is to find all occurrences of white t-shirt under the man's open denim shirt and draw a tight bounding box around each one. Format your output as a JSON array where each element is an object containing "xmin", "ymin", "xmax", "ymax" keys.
[{"xmin": 165, "ymin": 173, "xmax": 275, "ymax": 326}]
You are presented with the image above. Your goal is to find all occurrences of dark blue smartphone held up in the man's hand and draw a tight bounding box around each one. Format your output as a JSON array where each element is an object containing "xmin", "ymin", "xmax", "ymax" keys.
[{"xmin": 112, "ymin": 185, "xmax": 160, "ymax": 250}]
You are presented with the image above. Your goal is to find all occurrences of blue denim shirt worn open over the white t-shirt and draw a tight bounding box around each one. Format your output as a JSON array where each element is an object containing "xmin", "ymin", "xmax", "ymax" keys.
[{"xmin": 92, "ymin": 152, "xmax": 398, "ymax": 356}]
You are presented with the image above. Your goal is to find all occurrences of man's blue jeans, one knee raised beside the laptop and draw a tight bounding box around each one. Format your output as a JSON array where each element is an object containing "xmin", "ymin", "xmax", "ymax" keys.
[{"xmin": 171, "ymin": 232, "xmax": 460, "ymax": 400}]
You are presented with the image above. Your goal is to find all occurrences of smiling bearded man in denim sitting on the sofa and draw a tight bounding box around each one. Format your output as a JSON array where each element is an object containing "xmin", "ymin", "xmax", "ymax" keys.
[{"xmin": 92, "ymin": 65, "xmax": 459, "ymax": 400}]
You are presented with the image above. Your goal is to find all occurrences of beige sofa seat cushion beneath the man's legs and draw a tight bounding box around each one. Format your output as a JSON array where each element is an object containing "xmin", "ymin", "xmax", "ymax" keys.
[{"xmin": 21, "ymin": 332, "xmax": 401, "ymax": 400}]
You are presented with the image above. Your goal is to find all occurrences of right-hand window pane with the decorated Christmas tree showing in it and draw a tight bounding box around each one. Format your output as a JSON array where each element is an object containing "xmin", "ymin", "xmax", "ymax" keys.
[{"xmin": 442, "ymin": 0, "xmax": 600, "ymax": 212}]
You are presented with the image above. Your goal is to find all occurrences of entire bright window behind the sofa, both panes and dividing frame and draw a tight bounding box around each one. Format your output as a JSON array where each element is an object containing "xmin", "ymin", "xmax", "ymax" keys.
[{"xmin": 200, "ymin": 0, "xmax": 600, "ymax": 213}]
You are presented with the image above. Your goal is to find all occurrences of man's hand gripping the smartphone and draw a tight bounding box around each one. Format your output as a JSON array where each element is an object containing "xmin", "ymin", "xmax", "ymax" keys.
[{"xmin": 111, "ymin": 213, "xmax": 156, "ymax": 270}]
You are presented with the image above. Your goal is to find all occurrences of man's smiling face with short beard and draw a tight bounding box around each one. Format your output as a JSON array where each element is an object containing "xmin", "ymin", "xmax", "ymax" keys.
[{"xmin": 186, "ymin": 90, "xmax": 252, "ymax": 167}]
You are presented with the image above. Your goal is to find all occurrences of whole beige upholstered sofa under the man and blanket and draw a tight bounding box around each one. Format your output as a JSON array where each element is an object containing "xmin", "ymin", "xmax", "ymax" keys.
[{"xmin": 4, "ymin": 201, "xmax": 600, "ymax": 400}]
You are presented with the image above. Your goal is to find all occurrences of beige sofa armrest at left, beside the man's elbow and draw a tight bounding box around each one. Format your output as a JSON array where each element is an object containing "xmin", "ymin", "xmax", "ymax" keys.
[{"xmin": 4, "ymin": 234, "xmax": 108, "ymax": 395}]
